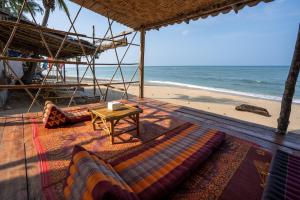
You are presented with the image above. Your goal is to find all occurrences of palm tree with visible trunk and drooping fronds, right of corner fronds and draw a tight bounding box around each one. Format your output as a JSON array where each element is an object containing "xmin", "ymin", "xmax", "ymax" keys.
[{"xmin": 42, "ymin": 0, "xmax": 69, "ymax": 26}]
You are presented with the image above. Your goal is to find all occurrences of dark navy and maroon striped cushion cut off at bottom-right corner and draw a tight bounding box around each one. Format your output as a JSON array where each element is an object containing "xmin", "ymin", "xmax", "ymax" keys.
[{"xmin": 263, "ymin": 150, "xmax": 300, "ymax": 199}]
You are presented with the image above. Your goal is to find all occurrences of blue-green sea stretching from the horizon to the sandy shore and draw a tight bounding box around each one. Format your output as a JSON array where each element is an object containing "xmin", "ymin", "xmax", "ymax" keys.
[{"xmin": 66, "ymin": 66, "xmax": 300, "ymax": 103}]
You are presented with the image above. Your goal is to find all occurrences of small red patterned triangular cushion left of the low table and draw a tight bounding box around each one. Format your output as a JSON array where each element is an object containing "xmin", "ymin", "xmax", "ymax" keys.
[{"xmin": 43, "ymin": 102, "xmax": 67, "ymax": 128}]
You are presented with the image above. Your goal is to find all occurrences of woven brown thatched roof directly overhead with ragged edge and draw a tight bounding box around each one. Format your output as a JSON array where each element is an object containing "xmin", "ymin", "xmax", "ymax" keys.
[{"xmin": 71, "ymin": 0, "xmax": 273, "ymax": 30}]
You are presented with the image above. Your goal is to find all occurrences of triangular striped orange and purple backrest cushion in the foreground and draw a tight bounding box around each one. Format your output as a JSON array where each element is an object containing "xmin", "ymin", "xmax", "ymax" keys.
[{"xmin": 64, "ymin": 146, "xmax": 138, "ymax": 200}]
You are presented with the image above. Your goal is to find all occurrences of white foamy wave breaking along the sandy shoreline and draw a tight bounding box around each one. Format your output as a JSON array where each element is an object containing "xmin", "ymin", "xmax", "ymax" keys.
[{"xmin": 147, "ymin": 80, "xmax": 300, "ymax": 103}]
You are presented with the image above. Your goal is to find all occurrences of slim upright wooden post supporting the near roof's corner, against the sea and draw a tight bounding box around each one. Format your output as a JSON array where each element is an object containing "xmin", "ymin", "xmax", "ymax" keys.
[{"xmin": 139, "ymin": 29, "xmax": 146, "ymax": 98}]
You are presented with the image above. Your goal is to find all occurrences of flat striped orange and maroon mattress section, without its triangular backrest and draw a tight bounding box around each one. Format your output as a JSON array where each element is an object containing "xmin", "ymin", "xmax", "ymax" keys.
[{"xmin": 110, "ymin": 123, "xmax": 225, "ymax": 200}]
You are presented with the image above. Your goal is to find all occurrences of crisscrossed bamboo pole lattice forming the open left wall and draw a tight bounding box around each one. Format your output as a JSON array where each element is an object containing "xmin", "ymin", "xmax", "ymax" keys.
[{"xmin": 0, "ymin": 0, "xmax": 140, "ymax": 112}]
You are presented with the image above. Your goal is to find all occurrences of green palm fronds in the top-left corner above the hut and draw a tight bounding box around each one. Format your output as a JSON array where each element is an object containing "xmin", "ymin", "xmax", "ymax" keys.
[{"xmin": 0, "ymin": 0, "xmax": 44, "ymax": 17}]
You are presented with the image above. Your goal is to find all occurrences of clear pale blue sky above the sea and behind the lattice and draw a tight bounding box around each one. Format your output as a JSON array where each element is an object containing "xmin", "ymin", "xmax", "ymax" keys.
[{"xmin": 31, "ymin": 0, "xmax": 300, "ymax": 65}]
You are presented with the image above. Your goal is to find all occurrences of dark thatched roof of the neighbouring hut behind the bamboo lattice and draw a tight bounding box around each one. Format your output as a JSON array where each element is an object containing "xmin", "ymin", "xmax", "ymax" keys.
[{"xmin": 0, "ymin": 11, "xmax": 127, "ymax": 58}]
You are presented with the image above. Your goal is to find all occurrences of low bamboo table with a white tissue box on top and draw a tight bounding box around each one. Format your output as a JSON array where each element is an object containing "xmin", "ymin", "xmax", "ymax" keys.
[{"xmin": 90, "ymin": 105, "xmax": 143, "ymax": 144}]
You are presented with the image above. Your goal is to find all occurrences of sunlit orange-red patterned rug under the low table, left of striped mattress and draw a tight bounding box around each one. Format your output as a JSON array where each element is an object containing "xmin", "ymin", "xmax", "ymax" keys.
[{"xmin": 30, "ymin": 104, "xmax": 186, "ymax": 199}]
